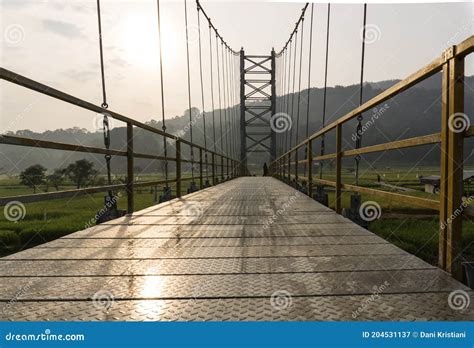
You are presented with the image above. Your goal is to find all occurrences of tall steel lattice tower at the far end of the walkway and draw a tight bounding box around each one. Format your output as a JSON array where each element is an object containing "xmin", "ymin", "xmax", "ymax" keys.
[{"xmin": 240, "ymin": 49, "xmax": 276, "ymax": 175}]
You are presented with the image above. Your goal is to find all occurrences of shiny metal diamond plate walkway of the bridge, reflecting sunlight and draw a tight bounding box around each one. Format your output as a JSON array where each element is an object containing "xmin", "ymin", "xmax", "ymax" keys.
[{"xmin": 0, "ymin": 177, "xmax": 474, "ymax": 321}]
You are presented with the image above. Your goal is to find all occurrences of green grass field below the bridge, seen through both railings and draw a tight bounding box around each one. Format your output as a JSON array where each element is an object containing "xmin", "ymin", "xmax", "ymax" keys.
[{"xmin": 0, "ymin": 168, "xmax": 474, "ymax": 264}]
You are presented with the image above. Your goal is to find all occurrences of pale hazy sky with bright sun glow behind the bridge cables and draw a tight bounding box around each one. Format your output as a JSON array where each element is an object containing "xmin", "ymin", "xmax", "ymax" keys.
[{"xmin": 0, "ymin": 0, "xmax": 474, "ymax": 132}]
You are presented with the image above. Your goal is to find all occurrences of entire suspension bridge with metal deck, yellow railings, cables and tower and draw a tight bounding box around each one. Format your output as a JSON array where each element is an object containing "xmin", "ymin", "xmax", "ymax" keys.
[{"xmin": 0, "ymin": 1, "xmax": 474, "ymax": 321}]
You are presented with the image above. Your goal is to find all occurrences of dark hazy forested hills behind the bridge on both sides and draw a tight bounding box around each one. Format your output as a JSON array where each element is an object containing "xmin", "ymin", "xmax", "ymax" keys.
[{"xmin": 0, "ymin": 75, "xmax": 474, "ymax": 174}]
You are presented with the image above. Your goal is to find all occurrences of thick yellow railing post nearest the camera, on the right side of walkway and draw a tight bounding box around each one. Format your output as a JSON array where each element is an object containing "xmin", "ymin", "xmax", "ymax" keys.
[{"xmin": 439, "ymin": 46, "xmax": 464, "ymax": 279}]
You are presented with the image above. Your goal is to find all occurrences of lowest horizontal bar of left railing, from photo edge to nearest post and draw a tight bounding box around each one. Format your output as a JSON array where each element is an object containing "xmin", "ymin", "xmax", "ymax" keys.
[{"xmin": 0, "ymin": 184, "xmax": 126, "ymax": 206}]
